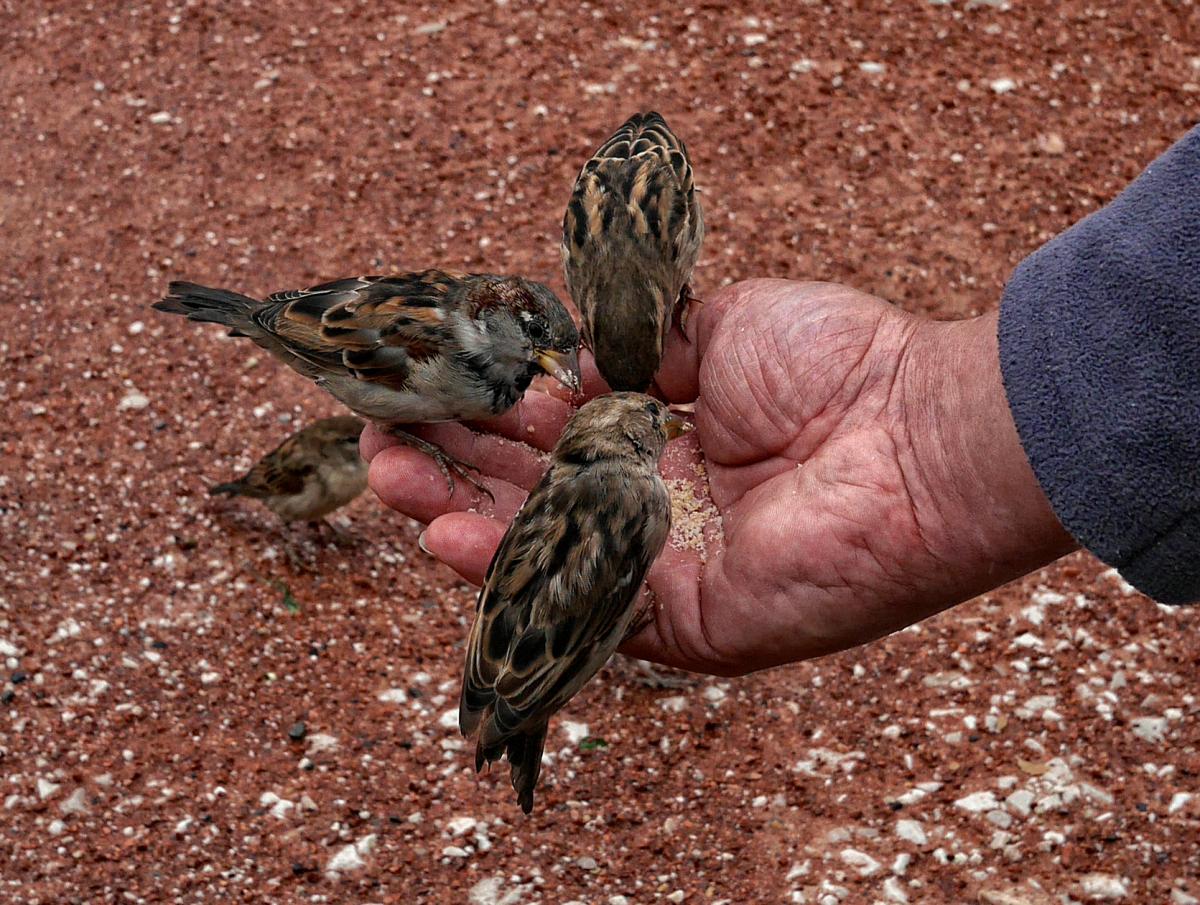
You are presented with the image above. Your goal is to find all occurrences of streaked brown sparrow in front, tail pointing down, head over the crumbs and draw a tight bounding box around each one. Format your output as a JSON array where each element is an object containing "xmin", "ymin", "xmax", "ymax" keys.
[{"xmin": 458, "ymin": 392, "xmax": 689, "ymax": 814}]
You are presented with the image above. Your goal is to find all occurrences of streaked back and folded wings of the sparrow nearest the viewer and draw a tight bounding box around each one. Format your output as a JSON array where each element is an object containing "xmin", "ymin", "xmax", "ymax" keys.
[{"xmin": 460, "ymin": 463, "xmax": 671, "ymax": 748}]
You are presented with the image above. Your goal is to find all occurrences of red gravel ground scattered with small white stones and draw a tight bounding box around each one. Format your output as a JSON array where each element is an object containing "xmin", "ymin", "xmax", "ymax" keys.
[{"xmin": 0, "ymin": 0, "xmax": 1200, "ymax": 905}]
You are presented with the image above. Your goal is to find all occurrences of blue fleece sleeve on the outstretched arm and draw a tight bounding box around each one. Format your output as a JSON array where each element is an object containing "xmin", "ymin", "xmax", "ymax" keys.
[{"xmin": 1000, "ymin": 127, "xmax": 1200, "ymax": 604}]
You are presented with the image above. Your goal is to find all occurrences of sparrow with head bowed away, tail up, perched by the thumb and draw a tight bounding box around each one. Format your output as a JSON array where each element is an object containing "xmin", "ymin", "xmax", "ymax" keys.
[{"xmin": 562, "ymin": 113, "xmax": 704, "ymax": 390}]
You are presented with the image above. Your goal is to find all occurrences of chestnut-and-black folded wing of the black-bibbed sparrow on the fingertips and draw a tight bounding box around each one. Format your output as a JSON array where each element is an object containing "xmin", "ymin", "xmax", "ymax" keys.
[{"xmin": 252, "ymin": 270, "xmax": 472, "ymax": 390}]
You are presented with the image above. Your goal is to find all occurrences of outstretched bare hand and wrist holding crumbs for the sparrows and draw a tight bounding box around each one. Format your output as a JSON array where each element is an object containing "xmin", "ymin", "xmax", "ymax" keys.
[{"xmin": 362, "ymin": 280, "xmax": 1075, "ymax": 675}]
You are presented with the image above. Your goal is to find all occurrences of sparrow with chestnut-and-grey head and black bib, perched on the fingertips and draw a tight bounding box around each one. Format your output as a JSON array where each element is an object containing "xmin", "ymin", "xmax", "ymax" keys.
[{"xmin": 154, "ymin": 270, "xmax": 580, "ymax": 496}]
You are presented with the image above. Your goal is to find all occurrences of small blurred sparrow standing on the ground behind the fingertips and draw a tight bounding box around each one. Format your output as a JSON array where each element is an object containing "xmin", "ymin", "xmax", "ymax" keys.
[{"xmin": 209, "ymin": 415, "xmax": 367, "ymax": 525}]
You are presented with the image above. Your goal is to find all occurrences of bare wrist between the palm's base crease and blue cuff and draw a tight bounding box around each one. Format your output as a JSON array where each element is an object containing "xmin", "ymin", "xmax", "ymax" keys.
[{"xmin": 896, "ymin": 313, "xmax": 1078, "ymax": 599}]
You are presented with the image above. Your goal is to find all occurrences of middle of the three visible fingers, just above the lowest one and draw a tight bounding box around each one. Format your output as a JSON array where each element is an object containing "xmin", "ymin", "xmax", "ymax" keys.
[{"xmin": 367, "ymin": 446, "xmax": 526, "ymax": 523}]
